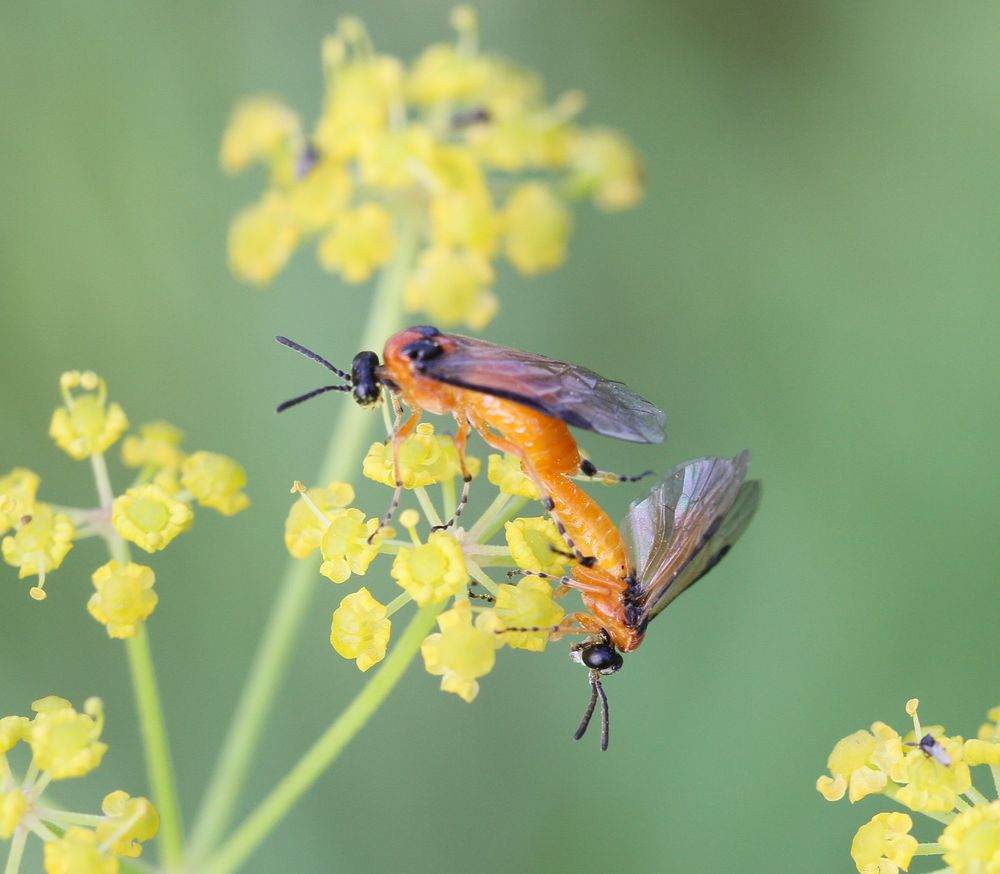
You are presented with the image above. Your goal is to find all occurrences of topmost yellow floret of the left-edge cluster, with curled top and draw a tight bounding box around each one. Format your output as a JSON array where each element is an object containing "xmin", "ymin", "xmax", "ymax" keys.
[{"xmin": 49, "ymin": 370, "xmax": 128, "ymax": 461}]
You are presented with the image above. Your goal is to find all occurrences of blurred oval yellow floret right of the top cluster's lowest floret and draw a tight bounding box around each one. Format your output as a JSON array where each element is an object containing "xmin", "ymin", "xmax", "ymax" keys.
[{"xmin": 504, "ymin": 182, "xmax": 573, "ymax": 276}]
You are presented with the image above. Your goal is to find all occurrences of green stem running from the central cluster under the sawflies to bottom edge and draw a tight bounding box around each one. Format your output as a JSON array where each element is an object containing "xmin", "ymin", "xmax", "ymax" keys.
[{"xmin": 200, "ymin": 604, "xmax": 445, "ymax": 874}]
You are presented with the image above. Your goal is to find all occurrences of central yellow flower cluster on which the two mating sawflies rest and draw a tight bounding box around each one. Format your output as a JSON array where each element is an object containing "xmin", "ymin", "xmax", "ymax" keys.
[{"xmin": 285, "ymin": 423, "xmax": 566, "ymax": 688}]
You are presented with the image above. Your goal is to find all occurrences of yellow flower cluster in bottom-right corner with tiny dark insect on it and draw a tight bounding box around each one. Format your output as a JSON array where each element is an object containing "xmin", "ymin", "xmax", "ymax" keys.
[{"xmin": 816, "ymin": 698, "xmax": 1000, "ymax": 874}]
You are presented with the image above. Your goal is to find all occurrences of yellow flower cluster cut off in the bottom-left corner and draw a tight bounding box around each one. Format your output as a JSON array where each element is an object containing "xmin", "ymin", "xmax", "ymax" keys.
[{"xmin": 0, "ymin": 695, "xmax": 159, "ymax": 874}]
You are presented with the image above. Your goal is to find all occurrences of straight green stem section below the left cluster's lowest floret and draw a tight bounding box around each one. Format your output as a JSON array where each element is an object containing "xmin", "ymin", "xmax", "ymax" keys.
[{"xmin": 125, "ymin": 625, "xmax": 184, "ymax": 868}]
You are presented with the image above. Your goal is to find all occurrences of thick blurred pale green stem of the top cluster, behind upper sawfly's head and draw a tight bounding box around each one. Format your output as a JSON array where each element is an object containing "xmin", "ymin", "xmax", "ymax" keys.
[{"xmin": 190, "ymin": 209, "xmax": 417, "ymax": 860}]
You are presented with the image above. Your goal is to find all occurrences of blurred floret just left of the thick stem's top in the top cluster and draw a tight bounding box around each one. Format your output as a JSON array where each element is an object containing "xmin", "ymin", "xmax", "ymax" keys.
[{"xmin": 316, "ymin": 202, "xmax": 396, "ymax": 283}]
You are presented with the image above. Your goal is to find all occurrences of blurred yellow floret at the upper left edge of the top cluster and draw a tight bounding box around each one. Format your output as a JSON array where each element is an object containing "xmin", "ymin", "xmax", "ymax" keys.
[{"xmin": 219, "ymin": 96, "xmax": 302, "ymax": 173}]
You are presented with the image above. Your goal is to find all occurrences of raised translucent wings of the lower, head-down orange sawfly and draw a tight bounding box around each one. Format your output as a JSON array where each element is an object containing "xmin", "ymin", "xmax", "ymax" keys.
[{"xmin": 622, "ymin": 451, "xmax": 761, "ymax": 622}]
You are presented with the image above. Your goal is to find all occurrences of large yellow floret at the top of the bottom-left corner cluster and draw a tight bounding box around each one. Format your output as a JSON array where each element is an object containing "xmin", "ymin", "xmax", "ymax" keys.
[{"xmin": 25, "ymin": 696, "xmax": 108, "ymax": 780}]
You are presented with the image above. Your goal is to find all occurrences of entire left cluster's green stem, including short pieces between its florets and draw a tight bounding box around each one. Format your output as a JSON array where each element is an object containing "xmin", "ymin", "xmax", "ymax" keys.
[{"xmin": 90, "ymin": 453, "xmax": 184, "ymax": 868}]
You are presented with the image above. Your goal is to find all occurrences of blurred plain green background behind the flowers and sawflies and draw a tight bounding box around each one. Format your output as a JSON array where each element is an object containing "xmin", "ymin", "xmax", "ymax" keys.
[{"xmin": 0, "ymin": 0, "xmax": 1000, "ymax": 872}]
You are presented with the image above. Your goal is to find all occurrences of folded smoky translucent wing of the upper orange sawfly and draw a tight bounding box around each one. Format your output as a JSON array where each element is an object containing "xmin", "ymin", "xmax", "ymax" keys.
[{"xmin": 417, "ymin": 334, "xmax": 666, "ymax": 443}]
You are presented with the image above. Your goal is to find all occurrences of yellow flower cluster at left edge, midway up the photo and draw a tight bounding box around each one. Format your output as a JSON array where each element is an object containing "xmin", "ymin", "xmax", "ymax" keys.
[{"xmin": 0, "ymin": 370, "xmax": 250, "ymax": 638}]
